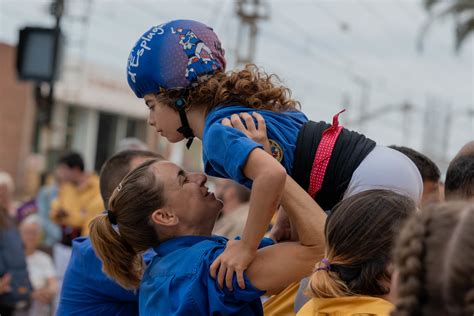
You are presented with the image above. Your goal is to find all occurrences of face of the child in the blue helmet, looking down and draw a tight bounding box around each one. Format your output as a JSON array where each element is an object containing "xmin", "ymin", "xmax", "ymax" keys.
[{"xmin": 144, "ymin": 93, "xmax": 184, "ymax": 143}]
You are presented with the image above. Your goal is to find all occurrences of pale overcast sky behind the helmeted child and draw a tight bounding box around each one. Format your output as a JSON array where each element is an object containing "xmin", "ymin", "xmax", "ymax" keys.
[{"xmin": 0, "ymin": 0, "xmax": 474, "ymax": 168}]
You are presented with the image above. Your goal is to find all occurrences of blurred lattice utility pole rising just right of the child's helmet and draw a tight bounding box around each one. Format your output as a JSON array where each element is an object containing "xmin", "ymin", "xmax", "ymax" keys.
[{"xmin": 236, "ymin": 0, "xmax": 270, "ymax": 66}]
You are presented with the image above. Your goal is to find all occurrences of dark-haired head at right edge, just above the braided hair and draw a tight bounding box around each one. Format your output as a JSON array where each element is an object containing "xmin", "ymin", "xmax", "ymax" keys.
[{"xmin": 444, "ymin": 152, "xmax": 474, "ymax": 200}]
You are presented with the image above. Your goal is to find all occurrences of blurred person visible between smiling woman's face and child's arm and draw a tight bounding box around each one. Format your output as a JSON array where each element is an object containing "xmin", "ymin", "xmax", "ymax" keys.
[{"xmin": 212, "ymin": 179, "xmax": 250, "ymax": 239}]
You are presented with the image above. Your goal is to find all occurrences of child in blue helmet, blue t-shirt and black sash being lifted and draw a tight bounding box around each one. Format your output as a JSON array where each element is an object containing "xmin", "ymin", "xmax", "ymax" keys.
[{"xmin": 127, "ymin": 20, "xmax": 422, "ymax": 287}]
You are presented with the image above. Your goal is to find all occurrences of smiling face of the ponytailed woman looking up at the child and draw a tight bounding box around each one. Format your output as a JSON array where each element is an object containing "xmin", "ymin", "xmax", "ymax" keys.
[{"xmin": 151, "ymin": 161, "xmax": 222, "ymax": 230}]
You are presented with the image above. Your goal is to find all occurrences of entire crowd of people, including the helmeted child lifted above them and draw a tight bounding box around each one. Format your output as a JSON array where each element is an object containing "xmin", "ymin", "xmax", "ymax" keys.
[{"xmin": 0, "ymin": 20, "xmax": 474, "ymax": 315}]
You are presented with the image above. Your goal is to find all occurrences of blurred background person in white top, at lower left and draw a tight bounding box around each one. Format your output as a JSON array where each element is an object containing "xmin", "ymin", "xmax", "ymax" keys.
[{"xmin": 20, "ymin": 214, "xmax": 58, "ymax": 316}]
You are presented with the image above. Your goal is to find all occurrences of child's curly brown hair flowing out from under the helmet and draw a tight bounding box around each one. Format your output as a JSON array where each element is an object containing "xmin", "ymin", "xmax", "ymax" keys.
[{"xmin": 157, "ymin": 65, "xmax": 300, "ymax": 113}]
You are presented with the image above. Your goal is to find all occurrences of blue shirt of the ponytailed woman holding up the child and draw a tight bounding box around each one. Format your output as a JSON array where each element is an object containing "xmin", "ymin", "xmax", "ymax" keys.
[{"xmin": 139, "ymin": 236, "xmax": 273, "ymax": 316}]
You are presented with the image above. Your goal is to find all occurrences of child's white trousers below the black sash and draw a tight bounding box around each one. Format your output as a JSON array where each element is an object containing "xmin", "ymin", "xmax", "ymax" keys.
[{"xmin": 344, "ymin": 146, "xmax": 423, "ymax": 203}]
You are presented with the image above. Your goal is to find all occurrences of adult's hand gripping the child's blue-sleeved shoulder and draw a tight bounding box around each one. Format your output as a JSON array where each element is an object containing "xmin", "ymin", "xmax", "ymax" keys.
[{"xmin": 221, "ymin": 112, "xmax": 272, "ymax": 154}]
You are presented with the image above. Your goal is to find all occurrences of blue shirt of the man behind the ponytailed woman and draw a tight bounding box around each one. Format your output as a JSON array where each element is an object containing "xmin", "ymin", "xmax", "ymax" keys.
[{"xmin": 56, "ymin": 237, "xmax": 154, "ymax": 316}]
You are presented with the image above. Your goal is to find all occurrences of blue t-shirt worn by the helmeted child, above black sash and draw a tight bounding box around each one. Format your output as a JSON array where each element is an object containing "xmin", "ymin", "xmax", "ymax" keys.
[{"xmin": 202, "ymin": 105, "xmax": 308, "ymax": 188}]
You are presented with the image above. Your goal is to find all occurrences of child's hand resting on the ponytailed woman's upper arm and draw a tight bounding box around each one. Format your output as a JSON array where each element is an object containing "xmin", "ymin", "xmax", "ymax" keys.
[{"xmin": 210, "ymin": 240, "xmax": 256, "ymax": 291}]
